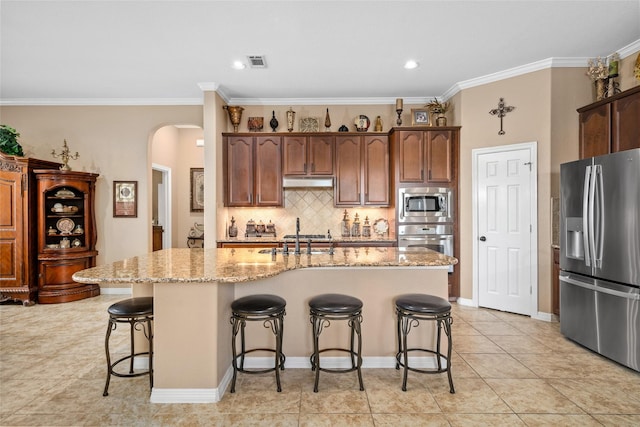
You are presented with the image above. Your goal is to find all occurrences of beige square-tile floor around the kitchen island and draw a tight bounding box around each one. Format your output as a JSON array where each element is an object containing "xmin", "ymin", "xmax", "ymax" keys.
[{"xmin": 0, "ymin": 295, "xmax": 640, "ymax": 427}]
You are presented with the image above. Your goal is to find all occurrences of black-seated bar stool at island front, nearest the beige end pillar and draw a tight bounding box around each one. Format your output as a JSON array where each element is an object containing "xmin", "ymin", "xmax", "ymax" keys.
[{"xmin": 230, "ymin": 294, "xmax": 287, "ymax": 393}]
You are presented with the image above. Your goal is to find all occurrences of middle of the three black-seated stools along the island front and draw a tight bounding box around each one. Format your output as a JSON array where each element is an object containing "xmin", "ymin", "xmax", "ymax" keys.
[{"xmin": 309, "ymin": 294, "xmax": 364, "ymax": 393}]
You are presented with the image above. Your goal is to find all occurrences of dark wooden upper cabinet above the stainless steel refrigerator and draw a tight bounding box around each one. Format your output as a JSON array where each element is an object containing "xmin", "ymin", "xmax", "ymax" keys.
[{"xmin": 578, "ymin": 86, "xmax": 640, "ymax": 159}]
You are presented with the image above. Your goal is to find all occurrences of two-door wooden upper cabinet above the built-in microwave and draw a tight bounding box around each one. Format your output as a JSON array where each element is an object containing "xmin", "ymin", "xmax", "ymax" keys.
[{"xmin": 393, "ymin": 127, "xmax": 458, "ymax": 186}]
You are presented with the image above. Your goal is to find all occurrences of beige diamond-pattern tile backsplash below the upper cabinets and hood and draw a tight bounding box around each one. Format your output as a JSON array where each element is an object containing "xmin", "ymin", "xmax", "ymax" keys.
[{"xmin": 218, "ymin": 188, "xmax": 395, "ymax": 238}]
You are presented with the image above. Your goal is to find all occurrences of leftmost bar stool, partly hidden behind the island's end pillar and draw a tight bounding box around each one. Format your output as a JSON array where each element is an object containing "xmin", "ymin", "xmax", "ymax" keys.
[{"xmin": 102, "ymin": 297, "xmax": 153, "ymax": 396}]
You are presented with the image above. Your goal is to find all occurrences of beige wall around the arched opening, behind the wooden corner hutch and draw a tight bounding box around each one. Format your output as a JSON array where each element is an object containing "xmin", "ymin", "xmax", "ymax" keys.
[{"xmin": 0, "ymin": 106, "xmax": 202, "ymax": 264}]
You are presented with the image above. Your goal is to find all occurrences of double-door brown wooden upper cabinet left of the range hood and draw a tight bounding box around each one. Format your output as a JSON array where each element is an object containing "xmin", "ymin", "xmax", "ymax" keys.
[{"xmin": 224, "ymin": 134, "xmax": 282, "ymax": 207}]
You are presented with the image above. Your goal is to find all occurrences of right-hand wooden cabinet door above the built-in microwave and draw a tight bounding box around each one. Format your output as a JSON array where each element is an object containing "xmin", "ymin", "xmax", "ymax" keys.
[{"xmin": 426, "ymin": 130, "xmax": 453, "ymax": 184}]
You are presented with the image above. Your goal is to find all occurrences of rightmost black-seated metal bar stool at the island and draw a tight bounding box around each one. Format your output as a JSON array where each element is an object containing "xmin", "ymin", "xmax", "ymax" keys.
[{"xmin": 395, "ymin": 294, "xmax": 455, "ymax": 393}]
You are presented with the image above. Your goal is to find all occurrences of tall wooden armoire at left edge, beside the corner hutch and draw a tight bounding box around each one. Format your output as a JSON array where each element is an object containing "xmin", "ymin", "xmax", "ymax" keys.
[{"xmin": 0, "ymin": 153, "xmax": 60, "ymax": 306}]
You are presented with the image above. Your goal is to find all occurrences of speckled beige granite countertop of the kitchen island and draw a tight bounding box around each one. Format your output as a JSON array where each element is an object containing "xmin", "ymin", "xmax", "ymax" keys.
[{"xmin": 73, "ymin": 247, "xmax": 458, "ymax": 283}]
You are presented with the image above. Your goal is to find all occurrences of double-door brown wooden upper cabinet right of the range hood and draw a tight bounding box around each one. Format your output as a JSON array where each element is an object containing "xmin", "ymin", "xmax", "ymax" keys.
[{"xmin": 334, "ymin": 134, "xmax": 389, "ymax": 206}]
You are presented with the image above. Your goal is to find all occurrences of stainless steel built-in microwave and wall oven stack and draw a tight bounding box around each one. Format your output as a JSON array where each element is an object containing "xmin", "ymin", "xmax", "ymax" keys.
[{"xmin": 396, "ymin": 187, "xmax": 454, "ymax": 273}]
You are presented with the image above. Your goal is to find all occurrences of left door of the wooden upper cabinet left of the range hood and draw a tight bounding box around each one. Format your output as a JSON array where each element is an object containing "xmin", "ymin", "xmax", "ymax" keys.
[{"xmin": 226, "ymin": 136, "xmax": 253, "ymax": 206}]
